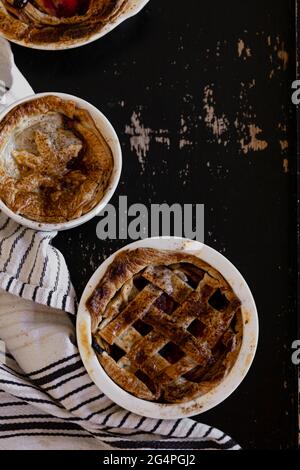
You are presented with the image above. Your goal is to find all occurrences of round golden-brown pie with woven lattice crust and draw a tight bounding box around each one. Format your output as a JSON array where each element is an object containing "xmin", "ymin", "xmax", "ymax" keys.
[{"xmin": 87, "ymin": 248, "xmax": 243, "ymax": 403}]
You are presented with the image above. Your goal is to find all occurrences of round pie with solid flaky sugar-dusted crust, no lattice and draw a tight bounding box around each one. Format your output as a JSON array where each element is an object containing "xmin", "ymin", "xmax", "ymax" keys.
[{"xmin": 0, "ymin": 95, "xmax": 113, "ymax": 223}]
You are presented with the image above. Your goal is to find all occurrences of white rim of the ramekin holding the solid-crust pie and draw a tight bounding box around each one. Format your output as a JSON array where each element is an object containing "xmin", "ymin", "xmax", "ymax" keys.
[{"xmin": 0, "ymin": 92, "xmax": 122, "ymax": 231}]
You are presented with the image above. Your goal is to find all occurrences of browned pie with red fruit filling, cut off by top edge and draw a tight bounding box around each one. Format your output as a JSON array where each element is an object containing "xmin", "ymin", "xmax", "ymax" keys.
[{"xmin": 0, "ymin": 0, "xmax": 129, "ymax": 46}]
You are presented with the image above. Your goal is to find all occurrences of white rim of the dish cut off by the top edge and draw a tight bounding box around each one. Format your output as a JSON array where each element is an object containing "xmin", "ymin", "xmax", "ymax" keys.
[{"xmin": 2, "ymin": 0, "xmax": 149, "ymax": 51}]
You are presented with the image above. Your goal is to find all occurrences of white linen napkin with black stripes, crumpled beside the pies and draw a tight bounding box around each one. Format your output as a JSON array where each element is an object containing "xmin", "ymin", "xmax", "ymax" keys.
[{"xmin": 0, "ymin": 41, "xmax": 240, "ymax": 450}]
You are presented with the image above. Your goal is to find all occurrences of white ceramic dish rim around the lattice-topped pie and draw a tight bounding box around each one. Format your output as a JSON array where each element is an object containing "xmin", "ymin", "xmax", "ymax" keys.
[{"xmin": 77, "ymin": 237, "xmax": 258, "ymax": 419}]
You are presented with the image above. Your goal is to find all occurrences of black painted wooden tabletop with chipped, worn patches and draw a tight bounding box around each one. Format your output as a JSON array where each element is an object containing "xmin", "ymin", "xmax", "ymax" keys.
[{"xmin": 13, "ymin": 0, "xmax": 297, "ymax": 449}]
